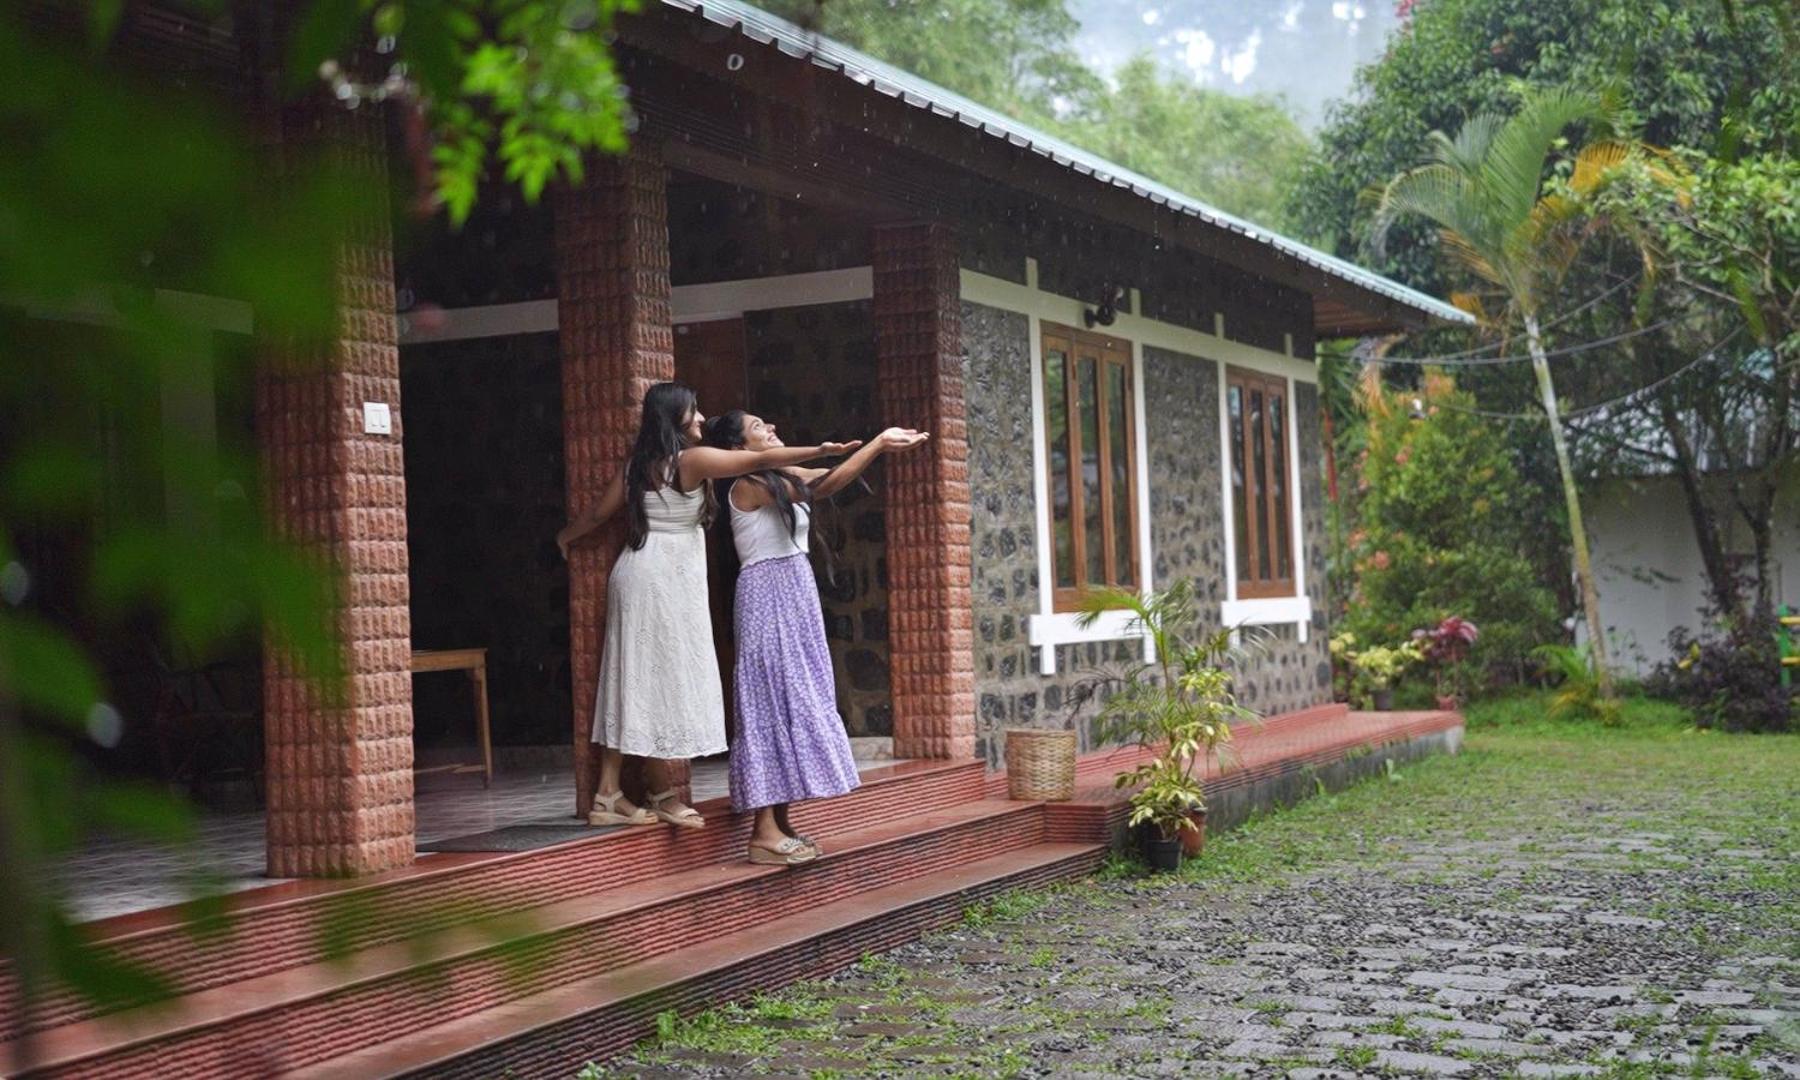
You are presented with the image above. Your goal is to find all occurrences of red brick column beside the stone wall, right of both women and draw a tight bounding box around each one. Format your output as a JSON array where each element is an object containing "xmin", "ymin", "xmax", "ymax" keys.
[{"xmin": 873, "ymin": 225, "xmax": 976, "ymax": 758}]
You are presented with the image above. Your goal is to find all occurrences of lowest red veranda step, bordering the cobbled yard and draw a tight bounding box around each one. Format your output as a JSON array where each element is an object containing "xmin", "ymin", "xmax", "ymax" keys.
[{"xmin": 293, "ymin": 844, "xmax": 1105, "ymax": 1080}]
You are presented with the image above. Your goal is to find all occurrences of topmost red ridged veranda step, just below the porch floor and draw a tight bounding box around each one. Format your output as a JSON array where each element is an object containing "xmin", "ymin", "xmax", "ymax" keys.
[{"xmin": 0, "ymin": 761, "xmax": 986, "ymax": 1042}]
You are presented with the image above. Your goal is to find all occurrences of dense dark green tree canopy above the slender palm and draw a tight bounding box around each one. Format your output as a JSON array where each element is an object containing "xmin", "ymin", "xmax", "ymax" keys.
[{"xmin": 1294, "ymin": 0, "xmax": 1800, "ymax": 293}]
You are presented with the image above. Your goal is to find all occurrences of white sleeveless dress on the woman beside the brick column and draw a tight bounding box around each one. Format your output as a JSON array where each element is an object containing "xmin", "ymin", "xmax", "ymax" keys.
[{"xmin": 594, "ymin": 486, "xmax": 725, "ymax": 758}]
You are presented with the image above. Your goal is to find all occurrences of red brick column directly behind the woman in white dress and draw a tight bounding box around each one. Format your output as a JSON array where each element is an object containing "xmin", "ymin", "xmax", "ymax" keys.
[{"xmin": 556, "ymin": 149, "xmax": 688, "ymax": 815}]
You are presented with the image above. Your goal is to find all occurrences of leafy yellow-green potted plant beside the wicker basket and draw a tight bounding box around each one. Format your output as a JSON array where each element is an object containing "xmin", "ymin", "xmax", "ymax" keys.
[{"xmin": 1075, "ymin": 581, "xmax": 1255, "ymax": 869}]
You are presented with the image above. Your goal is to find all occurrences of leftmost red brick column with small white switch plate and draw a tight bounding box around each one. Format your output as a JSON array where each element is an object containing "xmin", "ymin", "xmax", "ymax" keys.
[{"xmin": 256, "ymin": 108, "xmax": 412, "ymax": 877}]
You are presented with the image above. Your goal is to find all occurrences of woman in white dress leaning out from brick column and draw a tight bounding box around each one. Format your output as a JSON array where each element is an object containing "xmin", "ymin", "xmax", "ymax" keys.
[{"xmin": 556, "ymin": 383, "xmax": 859, "ymax": 828}]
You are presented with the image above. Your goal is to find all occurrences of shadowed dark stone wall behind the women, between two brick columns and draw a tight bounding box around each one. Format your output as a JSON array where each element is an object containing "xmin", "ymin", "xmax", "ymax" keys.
[{"xmin": 745, "ymin": 302, "xmax": 893, "ymax": 736}]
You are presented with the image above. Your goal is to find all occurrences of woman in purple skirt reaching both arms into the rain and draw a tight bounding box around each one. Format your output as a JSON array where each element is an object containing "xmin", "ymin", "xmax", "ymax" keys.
[{"xmin": 706, "ymin": 410, "xmax": 929, "ymax": 866}]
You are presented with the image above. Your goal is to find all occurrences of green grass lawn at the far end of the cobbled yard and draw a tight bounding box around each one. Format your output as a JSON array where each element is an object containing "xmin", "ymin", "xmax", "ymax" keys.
[{"xmin": 1159, "ymin": 693, "xmax": 1800, "ymax": 941}]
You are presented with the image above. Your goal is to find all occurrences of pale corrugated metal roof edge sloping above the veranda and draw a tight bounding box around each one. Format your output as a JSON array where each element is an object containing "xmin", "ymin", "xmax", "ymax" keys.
[{"xmin": 662, "ymin": 0, "xmax": 1474, "ymax": 322}]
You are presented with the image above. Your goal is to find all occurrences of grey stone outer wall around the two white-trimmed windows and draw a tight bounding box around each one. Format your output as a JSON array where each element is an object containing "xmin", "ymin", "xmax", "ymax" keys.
[{"xmin": 963, "ymin": 322, "xmax": 1330, "ymax": 763}]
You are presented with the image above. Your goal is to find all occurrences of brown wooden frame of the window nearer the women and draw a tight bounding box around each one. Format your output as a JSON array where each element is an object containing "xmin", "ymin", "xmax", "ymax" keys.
[{"xmin": 1039, "ymin": 322, "xmax": 1143, "ymax": 612}]
